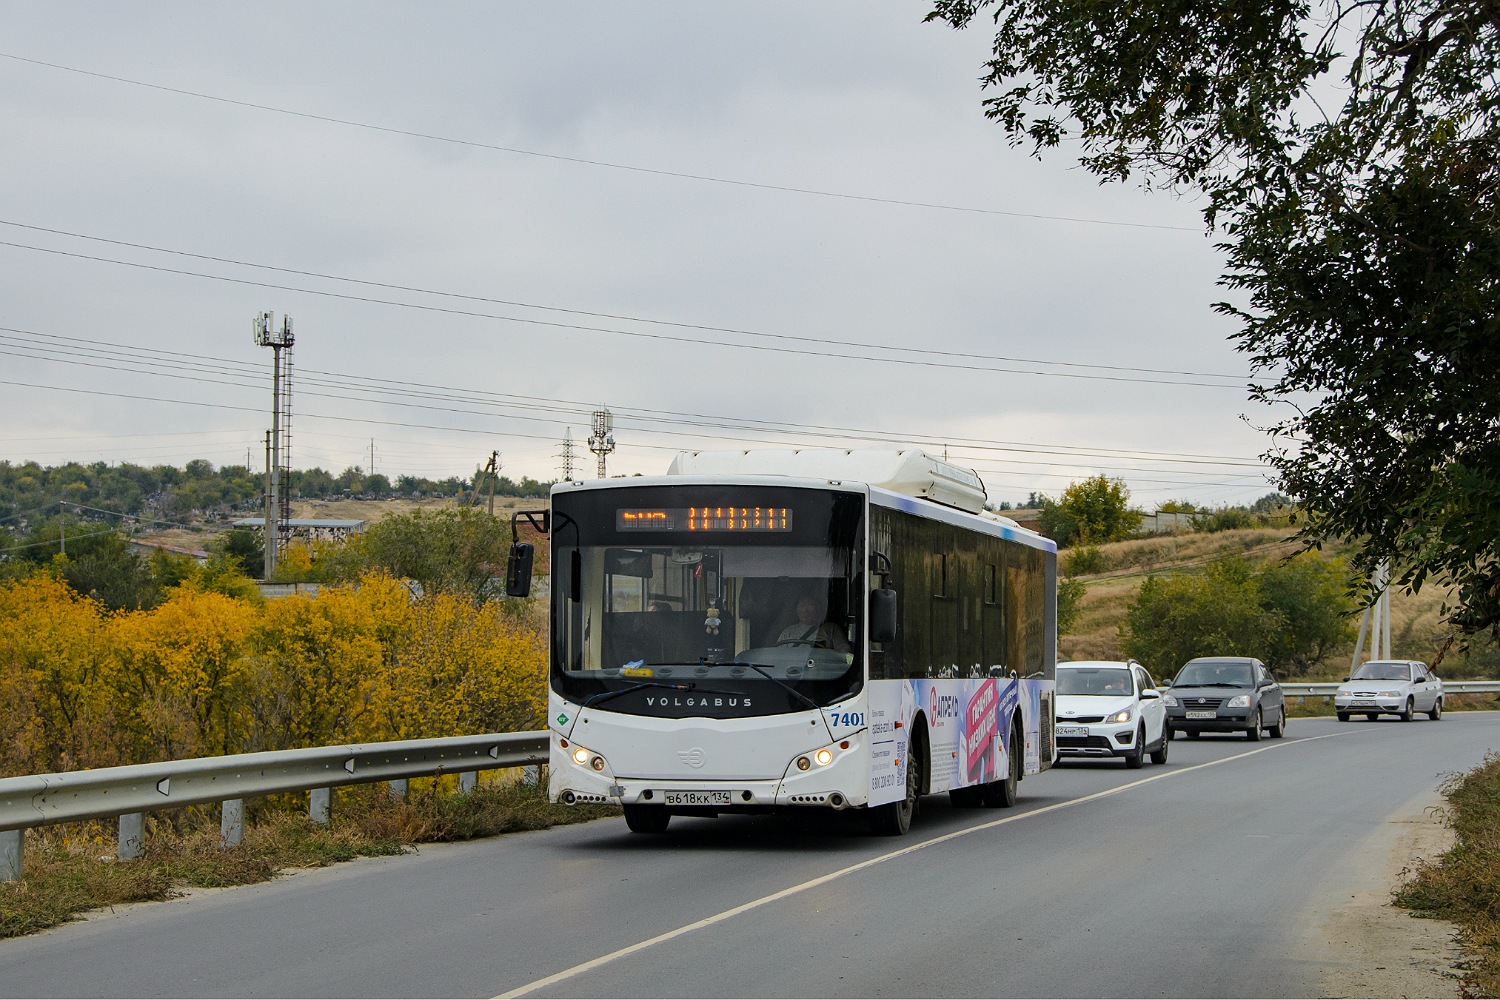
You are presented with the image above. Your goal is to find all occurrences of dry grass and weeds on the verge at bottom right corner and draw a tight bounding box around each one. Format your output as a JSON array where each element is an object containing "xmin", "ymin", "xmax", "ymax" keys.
[{"xmin": 1395, "ymin": 753, "xmax": 1500, "ymax": 997}]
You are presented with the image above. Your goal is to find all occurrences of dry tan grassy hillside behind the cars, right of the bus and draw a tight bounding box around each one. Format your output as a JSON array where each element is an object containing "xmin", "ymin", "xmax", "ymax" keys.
[{"xmin": 1058, "ymin": 528, "xmax": 1500, "ymax": 679}]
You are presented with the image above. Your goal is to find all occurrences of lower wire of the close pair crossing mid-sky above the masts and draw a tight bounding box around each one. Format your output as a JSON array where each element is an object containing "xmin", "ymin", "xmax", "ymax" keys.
[{"xmin": 0, "ymin": 240, "xmax": 1245, "ymax": 390}]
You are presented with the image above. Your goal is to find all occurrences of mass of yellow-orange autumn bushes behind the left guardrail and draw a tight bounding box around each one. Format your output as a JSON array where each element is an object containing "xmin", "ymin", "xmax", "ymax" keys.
[{"xmin": 0, "ymin": 573, "xmax": 546, "ymax": 775}]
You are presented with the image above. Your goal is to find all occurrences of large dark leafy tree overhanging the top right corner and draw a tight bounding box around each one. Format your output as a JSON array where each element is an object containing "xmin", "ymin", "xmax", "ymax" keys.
[{"xmin": 929, "ymin": 0, "xmax": 1500, "ymax": 634}]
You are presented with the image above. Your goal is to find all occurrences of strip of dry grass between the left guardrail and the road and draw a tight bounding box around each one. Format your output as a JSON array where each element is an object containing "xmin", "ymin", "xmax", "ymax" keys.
[{"xmin": 0, "ymin": 778, "xmax": 618, "ymax": 937}]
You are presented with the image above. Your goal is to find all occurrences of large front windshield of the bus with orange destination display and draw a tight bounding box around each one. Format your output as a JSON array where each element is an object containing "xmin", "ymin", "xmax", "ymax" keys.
[{"xmin": 552, "ymin": 486, "xmax": 864, "ymax": 718}]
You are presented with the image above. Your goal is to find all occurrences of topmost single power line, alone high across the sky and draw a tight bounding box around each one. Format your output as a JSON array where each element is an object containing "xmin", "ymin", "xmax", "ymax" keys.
[{"xmin": 0, "ymin": 52, "xmax": 1203, "ymax": 232}]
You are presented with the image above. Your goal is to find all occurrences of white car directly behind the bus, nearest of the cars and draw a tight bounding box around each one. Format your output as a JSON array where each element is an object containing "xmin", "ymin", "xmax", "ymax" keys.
[{"xmin": 1053, "ymin": 660, "xmax": 1172, "ymax": 768}]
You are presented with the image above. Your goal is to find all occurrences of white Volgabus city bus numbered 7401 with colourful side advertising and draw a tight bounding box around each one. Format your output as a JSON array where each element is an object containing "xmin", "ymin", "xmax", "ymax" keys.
[{"xmin": 507, "ymin": 450, "xmax": 1056, "ymax": 834}]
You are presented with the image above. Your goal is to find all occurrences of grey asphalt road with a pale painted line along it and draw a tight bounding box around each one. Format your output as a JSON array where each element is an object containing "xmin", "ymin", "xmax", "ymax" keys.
[{"xmin": 0, "ymin": 712, "xmax": 1500, "ymax": 997}]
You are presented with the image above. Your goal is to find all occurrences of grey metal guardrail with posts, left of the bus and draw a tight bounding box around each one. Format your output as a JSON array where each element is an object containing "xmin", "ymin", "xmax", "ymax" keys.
[{"xmin": 0, "ymin": 730, "xmax": 548, "ymax": 882}]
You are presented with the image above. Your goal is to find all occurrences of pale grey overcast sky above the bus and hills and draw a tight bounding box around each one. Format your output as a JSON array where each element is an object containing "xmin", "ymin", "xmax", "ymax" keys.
[{"xmin": 0, "ymin": 0, "xmax": 1290, "ymax": 508}]
